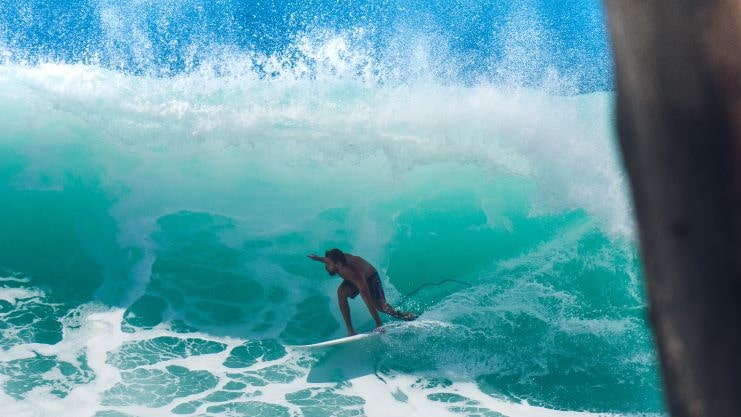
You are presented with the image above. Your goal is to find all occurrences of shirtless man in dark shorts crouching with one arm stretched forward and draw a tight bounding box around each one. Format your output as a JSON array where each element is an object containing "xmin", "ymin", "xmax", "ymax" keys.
[{"xmin": 309, "ymin": 249, "xmax": 417, "ymax": 336}]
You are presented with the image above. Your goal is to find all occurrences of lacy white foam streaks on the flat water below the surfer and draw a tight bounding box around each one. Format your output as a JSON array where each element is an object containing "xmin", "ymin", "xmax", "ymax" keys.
[{"xmin": 0, "ymin": 300, "xmax": 656, "ymax": 417}]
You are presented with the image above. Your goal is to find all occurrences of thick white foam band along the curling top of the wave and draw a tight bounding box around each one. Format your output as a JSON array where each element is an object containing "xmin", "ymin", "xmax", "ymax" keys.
[{"xmin": 0, "ymin": 59, "xmax": 632, "ymax": 236}]
